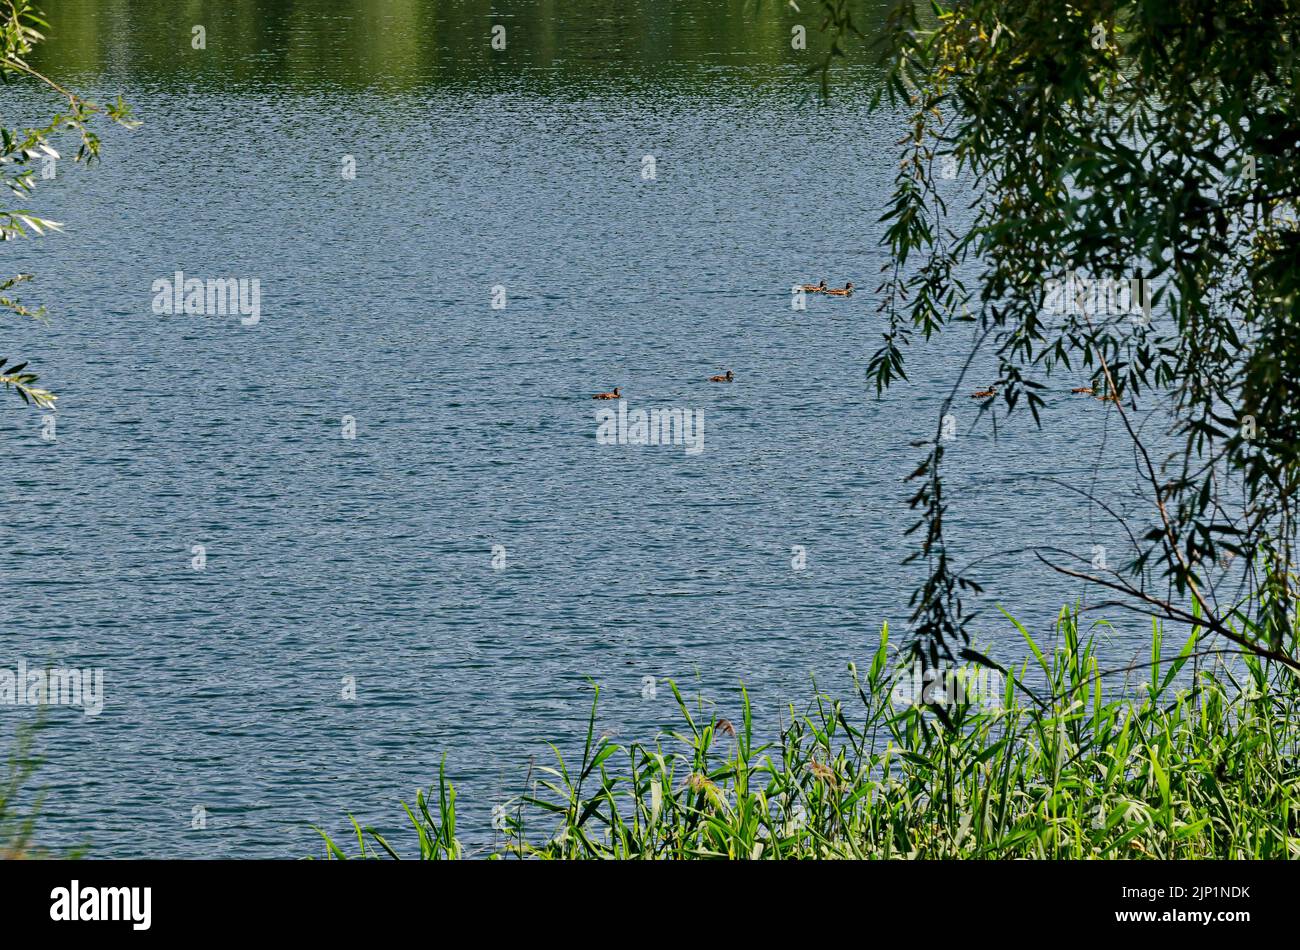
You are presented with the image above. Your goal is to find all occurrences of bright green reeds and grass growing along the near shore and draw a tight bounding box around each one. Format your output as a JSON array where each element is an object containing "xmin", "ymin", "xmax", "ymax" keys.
[{"xmin": 316, "ymin": 610, "xmax": 1300, "ymax": 860}]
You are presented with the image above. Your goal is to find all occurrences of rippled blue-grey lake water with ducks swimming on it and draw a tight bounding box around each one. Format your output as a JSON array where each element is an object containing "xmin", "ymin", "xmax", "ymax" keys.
[{"xmin": 0, "ymin": 0, "xmax": 1147, "ymax": 858}]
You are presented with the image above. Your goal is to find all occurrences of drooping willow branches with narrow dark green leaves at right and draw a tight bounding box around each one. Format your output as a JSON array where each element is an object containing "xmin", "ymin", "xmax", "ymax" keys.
[{"xmin": 837, "ymin": 0, "xmax": 1300, "ymax": 669}]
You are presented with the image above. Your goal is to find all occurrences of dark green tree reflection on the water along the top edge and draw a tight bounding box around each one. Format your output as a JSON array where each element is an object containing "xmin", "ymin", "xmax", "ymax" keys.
[{"xmin": 39, "ymin": 0, "xmax": 887, "ymax": 92}]
